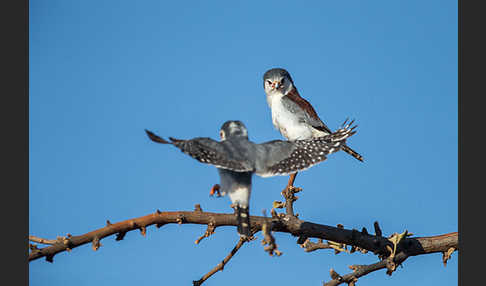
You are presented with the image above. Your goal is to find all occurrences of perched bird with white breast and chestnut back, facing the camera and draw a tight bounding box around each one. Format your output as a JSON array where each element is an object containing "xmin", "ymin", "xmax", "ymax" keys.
[{"xmin": 263, "ymin": 68, "xmax": 363, "ymax": 188}]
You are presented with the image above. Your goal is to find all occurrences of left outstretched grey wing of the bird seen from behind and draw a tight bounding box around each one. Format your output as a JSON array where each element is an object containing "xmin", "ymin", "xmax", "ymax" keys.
[{"xmin": 145, "ymin": 130, "xmax": 253, "ymax": 172}]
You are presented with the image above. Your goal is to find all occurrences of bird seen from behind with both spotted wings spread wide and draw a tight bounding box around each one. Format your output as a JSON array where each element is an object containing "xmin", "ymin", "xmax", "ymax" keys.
[{"xmin": 145, "ymin": 120, "xmax": 356, "ymax": 239}]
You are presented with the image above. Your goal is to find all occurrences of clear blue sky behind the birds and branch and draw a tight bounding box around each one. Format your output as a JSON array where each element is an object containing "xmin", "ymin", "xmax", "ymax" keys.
[{"xmin": 29, "ymin": 0, "xmax": 458, "ymax": 286}]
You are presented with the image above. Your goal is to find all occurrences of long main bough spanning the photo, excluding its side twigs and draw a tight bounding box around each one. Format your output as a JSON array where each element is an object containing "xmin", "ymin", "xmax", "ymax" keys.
[{"xmin": 28, "ymin": 210, "xmax": 458, "ymax": 261}]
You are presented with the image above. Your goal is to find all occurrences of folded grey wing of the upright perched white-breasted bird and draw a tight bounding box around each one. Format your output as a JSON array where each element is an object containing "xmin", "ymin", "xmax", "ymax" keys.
[{"xmin": 282, "ymin": 95, "xmax": 332, "ymax": 134}]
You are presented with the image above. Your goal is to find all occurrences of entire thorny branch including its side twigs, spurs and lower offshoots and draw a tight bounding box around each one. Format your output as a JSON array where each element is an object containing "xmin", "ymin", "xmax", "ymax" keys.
[{"xmin": 28, "ymin": 187, "xmax": 458, "ymax": 286}]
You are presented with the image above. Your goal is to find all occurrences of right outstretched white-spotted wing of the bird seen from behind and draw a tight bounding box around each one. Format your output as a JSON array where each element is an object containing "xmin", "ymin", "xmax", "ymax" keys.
[{"xmin": 255, "ymin": 126, "xmax": 356, "ymax": 177}]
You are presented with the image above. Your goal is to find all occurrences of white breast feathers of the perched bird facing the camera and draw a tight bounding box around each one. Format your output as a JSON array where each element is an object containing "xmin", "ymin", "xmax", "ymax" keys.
[{"xmin": 268, "ymin": 95, "xmax": 312, "ymax": 140}]
